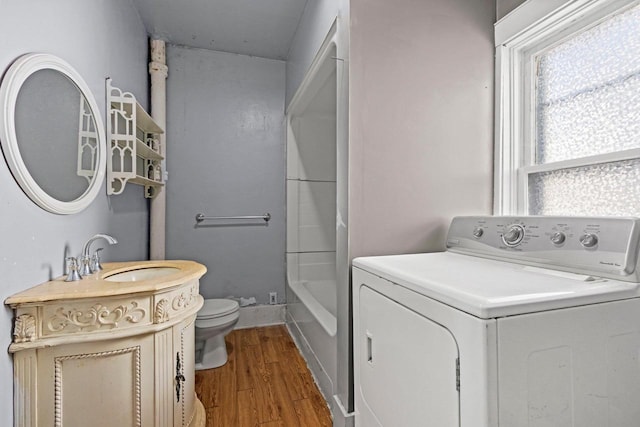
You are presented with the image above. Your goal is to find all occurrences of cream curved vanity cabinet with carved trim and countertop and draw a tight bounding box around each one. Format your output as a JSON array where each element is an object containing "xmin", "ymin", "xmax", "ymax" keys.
[{"xmin": 5, "ymin": 261, "xmax": 206, "ymax": 427}]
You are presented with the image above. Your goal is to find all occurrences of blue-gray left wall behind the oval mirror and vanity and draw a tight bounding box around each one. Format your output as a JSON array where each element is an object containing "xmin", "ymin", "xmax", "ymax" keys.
[{"xmin": 0, "ymin": 0, "xmax": 148, "ymax": 426}]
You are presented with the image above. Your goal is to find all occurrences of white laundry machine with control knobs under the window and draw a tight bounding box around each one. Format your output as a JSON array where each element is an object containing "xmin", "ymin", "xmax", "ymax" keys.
[{"xmin": 353, "ymin": 217, "xmax": 640, "ymax": 427}]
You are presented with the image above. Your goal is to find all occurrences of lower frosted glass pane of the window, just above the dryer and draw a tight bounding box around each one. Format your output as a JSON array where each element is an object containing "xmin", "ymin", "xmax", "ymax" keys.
[{"xmin": 529, "ymin": 159, "xmax": 640, "ymax": 216}]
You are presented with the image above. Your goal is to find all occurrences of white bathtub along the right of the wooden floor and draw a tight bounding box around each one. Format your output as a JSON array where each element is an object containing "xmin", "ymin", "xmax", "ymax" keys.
[{"xmin": 287, "ymin": 280, "xmax": 338, "ymax": 402}]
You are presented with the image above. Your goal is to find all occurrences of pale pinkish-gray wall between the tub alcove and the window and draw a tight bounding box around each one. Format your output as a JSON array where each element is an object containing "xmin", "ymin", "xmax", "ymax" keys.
[{"xmin": 349, "ymin": 0, "xmax": 495, "ymax": 257}]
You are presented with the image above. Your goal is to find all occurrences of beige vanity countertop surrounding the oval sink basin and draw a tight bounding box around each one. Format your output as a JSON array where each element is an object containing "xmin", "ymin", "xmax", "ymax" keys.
[{"xmin": 5, "ymin": 260, "xmax": 207, "ymax": 308}]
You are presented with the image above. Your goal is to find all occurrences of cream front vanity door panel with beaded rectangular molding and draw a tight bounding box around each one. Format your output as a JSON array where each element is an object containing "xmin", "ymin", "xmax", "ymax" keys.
[{"xmin": 37, "ymin": 335, "xmax": 154, "ymax": 427}]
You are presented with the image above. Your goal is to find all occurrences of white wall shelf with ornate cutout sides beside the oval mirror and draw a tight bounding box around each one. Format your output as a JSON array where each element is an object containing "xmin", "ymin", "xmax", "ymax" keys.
[{"xmin": 107, "ymin": 79, "xmax": 164, "ymax": 199}]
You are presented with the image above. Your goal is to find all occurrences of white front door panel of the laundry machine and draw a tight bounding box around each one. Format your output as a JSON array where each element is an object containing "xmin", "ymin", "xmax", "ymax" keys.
[{"xmin": 354, "ymin": 286, "xmax": 460, "ymax": 427}]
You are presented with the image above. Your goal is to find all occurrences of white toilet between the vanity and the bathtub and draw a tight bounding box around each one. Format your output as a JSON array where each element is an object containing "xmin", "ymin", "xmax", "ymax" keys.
[{"xmin": 196, "ymin": 299, "xmax": 240, "ymax": 370}]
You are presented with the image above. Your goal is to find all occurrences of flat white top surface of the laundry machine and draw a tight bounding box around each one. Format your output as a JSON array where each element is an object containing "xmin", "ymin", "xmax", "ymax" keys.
[{"xmin": 353, "ymin": 252, "xmax": 640, "ymax": 319}]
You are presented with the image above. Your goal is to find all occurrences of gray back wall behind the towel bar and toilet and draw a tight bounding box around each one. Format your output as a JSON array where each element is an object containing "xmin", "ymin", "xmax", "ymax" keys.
[{"xmin": 166, "ymin": 45, "xmax": 285, "ymax": 304}]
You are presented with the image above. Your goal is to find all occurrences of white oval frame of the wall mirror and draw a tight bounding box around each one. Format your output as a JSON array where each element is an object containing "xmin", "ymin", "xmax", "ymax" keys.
[{"xmin": 0, "ymin": 53, "xmax": 107, "ymax": 215}]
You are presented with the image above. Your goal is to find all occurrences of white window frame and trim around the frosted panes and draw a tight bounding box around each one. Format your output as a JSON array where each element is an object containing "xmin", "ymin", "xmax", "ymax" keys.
[{"xmin": 494, "ymin": 0, "xmax": 640, "ymax": 215}]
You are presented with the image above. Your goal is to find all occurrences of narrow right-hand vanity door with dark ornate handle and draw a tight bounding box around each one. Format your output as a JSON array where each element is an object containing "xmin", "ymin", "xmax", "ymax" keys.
[{"xmin": 173, "ymin": 316, "xmax": 196, "ymax": 426}]
